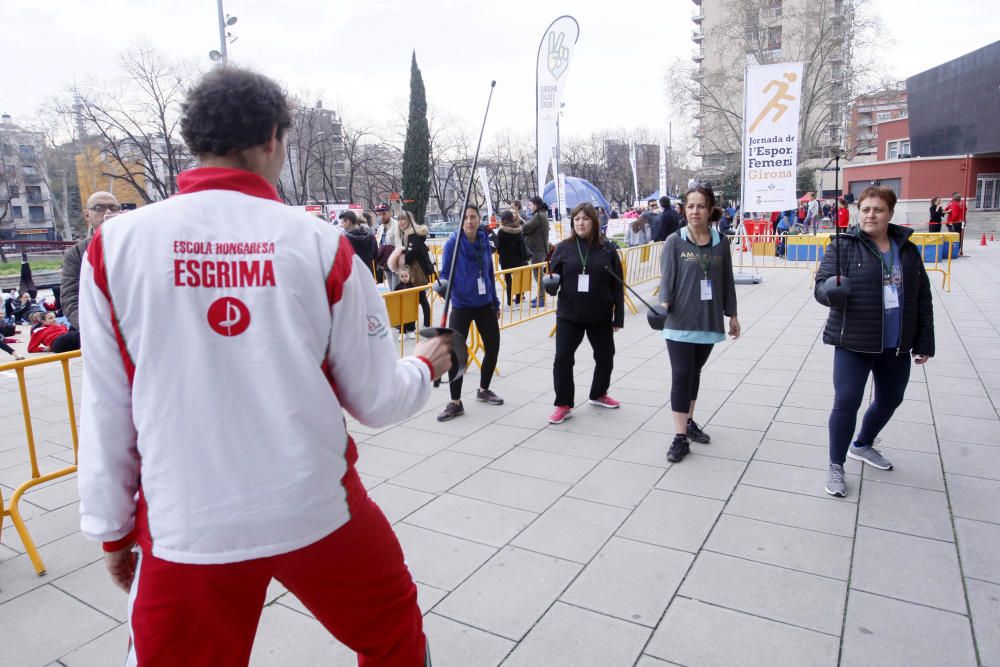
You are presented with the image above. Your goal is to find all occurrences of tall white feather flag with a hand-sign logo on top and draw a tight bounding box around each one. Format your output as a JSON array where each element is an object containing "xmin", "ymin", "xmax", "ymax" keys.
[{"xmin": 535, "ymin": 16, "xmax": 580, "ymax": 195}]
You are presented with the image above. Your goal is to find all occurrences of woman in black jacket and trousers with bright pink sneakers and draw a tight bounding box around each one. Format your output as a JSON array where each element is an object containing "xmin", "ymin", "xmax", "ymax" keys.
[{"xmin": 549, "ymin": 204, "xmax": 625, "ymax": 424}]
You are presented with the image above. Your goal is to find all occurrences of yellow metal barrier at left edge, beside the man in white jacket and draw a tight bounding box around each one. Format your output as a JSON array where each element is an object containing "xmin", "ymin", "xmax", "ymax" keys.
[{"xmin": 0, "ymin": 351, "xmax": 80, "ymax": 576}]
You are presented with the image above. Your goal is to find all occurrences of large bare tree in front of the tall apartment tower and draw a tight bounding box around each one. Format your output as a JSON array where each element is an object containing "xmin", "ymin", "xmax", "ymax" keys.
[{"xmin": 665, "ymin": 0, "xmax": 879, "ymax": 179}]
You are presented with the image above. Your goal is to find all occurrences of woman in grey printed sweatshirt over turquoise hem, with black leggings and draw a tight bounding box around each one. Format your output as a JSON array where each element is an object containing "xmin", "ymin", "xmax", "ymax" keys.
[{"xmin": 660, "ymin": 186, "xmax": 740, "ymax": 463}]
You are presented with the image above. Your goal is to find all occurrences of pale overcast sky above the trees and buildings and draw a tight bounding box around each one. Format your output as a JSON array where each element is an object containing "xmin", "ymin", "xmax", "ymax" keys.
[{"xmin": 0, "ymin": 0, "xmax": 1000, "ymax": 141}]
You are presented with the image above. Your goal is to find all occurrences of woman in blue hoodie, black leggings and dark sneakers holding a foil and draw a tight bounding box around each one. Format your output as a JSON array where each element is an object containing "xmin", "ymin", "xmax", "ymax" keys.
[{"xmin": 438, "ymin": 205, "xmax": 503, "ymax": 422}]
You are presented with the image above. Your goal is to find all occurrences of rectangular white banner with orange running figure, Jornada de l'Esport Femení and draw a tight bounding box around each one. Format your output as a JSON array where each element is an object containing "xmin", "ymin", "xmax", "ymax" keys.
[{"xmin": 742, "ymin": 63, "xmax": 802, "ymax": 211}]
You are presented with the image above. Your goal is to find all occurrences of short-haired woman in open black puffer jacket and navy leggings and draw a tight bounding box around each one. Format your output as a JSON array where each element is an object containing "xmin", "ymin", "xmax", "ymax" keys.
[{"xmin": 815, "ymin": 187, "xmax": 934, "ymax": 498}]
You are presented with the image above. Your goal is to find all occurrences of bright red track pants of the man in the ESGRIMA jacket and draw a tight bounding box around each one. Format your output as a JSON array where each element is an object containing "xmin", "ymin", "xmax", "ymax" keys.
[{"xmin": 128, "ymin": 497, "xmax": 426, "ymax": 667}]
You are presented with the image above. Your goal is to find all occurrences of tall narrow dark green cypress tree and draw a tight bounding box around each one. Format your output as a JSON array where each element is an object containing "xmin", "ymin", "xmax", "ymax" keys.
[{"xmin": 403, "ymin": 51, "xmax": 431, "ymax": 225}]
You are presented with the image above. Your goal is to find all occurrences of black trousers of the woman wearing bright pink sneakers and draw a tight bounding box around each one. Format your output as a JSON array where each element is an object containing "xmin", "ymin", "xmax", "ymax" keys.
[{"xmin": 552, "ymin": 317, "xmax": 615, "ymax": 407}]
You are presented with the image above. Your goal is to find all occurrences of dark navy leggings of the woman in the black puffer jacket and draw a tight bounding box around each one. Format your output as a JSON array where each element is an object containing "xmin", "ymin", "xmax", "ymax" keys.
[{"xmin": 830, "ymin": 347, "xmax": 911, "ymax": 465}]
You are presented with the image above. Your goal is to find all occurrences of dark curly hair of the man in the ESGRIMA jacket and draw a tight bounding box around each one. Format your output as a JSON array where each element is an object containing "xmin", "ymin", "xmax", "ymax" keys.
[{"xmin": 181, "ymin": 67, "xmax": 292, "ymax": 157}]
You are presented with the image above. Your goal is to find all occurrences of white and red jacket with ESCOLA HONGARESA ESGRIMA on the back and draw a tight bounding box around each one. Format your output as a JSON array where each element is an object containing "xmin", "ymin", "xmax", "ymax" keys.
[{"xmin": 79, "ymin": 167, "xmax": 431, "ymax": 563}]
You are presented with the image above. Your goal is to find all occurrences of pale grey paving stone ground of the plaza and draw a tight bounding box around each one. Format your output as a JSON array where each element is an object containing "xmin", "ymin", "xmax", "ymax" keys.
[{"xmin": 0, "ymin": 245, "xmax": 1000, "ymax": 667}]
